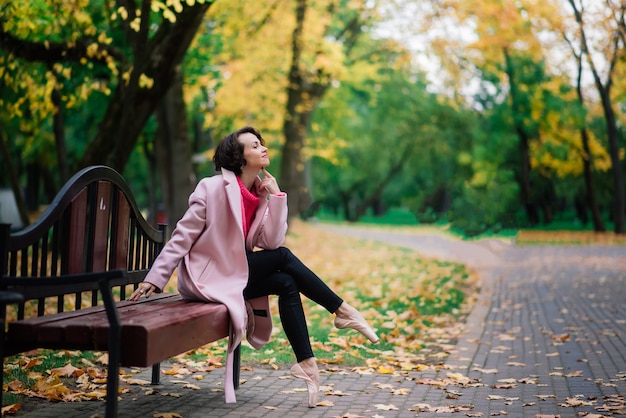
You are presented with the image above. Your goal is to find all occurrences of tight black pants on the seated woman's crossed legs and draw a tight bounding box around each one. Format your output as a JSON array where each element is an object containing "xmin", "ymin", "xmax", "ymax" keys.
[{"xmin": 243, "ymin": 247, "xmax": 343, "ymax": 362}]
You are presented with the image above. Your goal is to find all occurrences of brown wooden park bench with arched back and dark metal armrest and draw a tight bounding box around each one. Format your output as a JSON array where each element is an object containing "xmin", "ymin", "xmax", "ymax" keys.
[{"xmin": 0, "ymin": 166, "xmax": 239, "ymax": 417}]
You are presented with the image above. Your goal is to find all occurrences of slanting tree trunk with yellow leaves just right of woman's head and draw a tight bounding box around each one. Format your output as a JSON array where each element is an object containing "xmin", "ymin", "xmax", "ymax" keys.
[{"xmin": 280, "ymin": 0, "xmax": 373, "ymax": 217}]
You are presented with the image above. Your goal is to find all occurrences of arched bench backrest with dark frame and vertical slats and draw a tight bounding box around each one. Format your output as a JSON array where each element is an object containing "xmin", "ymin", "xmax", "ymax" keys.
[{"xmin": 0, "ymin": 166, "xmax": 165, "ymax": 314}]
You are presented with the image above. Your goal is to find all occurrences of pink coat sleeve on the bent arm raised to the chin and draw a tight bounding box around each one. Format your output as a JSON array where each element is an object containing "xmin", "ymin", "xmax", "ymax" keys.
[{"xmin": 249, "ymin": 193, "xmax": 287, "ymax": 250}]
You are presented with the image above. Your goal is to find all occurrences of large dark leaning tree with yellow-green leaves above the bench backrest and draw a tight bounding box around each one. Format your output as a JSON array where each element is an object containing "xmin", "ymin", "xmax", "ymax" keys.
[{"xmin": 0, "ymin": 0, "xmax": 211, "ymax": 186}]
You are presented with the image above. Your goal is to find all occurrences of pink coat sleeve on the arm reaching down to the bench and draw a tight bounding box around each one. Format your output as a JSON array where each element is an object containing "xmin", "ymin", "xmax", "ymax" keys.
[{"xmin": 144, "ymin": 179, "xmax": 208, "ymax": 293}]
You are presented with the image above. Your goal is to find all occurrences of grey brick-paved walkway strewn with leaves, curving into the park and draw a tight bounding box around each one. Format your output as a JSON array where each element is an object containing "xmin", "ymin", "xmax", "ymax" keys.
[{"xmin": 13, "ymin": 226, "xmax": 626, "ymax": 418}]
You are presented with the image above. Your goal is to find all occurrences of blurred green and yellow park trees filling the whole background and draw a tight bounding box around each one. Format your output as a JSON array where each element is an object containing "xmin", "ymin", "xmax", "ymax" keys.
[{"xmin": 0, "ymin": 0, "xmax": 626, "ymax": 235}]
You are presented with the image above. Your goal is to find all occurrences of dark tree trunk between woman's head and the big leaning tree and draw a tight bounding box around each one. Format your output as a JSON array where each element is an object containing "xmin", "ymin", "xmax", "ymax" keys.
[{"xmin": 156, "ymin": 71, "xmax": 195, "ymax": 234}]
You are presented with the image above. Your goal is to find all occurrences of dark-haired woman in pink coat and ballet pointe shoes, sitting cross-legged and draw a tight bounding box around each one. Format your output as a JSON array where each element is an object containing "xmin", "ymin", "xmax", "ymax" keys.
[{"xmin": 130, "ymin": 127, "xmax": 378, "ymax": 407}]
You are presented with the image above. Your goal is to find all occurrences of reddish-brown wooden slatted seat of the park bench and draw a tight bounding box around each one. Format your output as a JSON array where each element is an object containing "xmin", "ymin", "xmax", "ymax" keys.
[{"xmin": 7, "ymin": 294, "xmax": 228, "ymax": 367}]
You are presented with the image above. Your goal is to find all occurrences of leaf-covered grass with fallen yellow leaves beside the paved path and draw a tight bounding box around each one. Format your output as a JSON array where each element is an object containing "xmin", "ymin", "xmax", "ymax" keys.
[{"xmin": 3, "ymin": 222, "xmax": 478, "ymax": 414}]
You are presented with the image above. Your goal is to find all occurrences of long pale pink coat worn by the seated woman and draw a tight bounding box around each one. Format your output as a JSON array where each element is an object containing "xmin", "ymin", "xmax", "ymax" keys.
[{"xmin": 145, "ymin": 169, "xmax": 287, "ymax": 403}]
